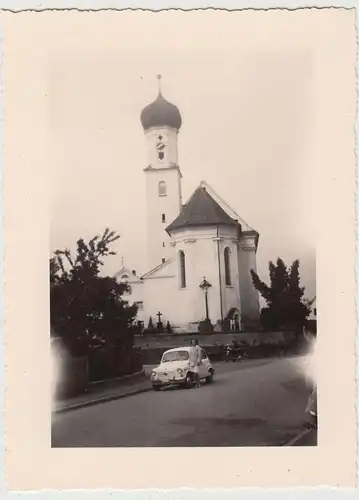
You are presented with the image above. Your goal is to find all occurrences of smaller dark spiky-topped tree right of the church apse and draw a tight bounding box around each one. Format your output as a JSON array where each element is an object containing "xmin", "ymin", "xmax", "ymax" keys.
[{"xmin": 251, "ymin": 258, "xmax": 313, "ymax": 331}]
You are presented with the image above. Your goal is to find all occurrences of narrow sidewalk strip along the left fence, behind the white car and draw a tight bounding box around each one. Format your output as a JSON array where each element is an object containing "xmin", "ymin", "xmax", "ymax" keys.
[{"xmin": 52, "ymin": 370, "xmax": 152, "ymax": 413}]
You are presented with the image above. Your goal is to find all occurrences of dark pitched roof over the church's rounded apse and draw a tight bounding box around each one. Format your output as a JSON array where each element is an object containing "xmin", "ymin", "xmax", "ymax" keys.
[{"xmin": 166, "ymin": 186, "xmax": 238, "ymax": 232}]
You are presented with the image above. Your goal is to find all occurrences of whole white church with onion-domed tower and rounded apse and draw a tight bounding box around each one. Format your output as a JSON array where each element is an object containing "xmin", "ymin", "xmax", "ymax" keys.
[{"xmin": 115, "ymin": 80, "xmax": 260, "ymax": 333}]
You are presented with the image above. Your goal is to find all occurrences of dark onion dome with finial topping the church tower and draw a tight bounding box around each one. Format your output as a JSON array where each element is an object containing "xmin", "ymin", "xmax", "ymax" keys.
[{"xmin": 141, "ymin": 77, "xmax": 182, "ymax": 130}]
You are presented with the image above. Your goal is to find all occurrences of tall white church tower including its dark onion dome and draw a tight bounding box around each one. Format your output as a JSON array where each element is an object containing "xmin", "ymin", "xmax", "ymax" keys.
[{"xmin": 141, "ymin": 76, "xmax": 182, "ymax": 269}]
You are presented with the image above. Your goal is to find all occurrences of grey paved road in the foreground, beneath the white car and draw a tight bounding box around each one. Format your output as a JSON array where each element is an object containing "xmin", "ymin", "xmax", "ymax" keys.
[{"xmin": 52, "ymin": 358, "xmax": 316, "ymax": 447}]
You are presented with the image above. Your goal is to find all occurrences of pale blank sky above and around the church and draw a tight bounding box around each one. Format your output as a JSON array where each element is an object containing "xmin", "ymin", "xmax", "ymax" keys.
[{"xmin": 47, "ymin": 10, "xmax": 318, "ymax": 297}]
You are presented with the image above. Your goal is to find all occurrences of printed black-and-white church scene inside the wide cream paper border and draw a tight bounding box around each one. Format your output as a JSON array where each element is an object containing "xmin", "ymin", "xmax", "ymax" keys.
[{"xmin": 48, "ymin": 14, "xmax": 317, "ymax": 447}]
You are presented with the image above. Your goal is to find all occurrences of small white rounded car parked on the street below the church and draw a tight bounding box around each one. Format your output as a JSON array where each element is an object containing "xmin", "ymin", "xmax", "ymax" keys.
[{"xmin": 151, "ymin": 347, "xmax": 214, "ymax": 391}]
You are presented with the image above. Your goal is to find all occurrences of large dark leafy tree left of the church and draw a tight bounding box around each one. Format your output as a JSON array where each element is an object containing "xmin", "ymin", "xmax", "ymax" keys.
[{"xmin": 50, "ymin": 229, "xmax": 137, "ymax": 354}]
